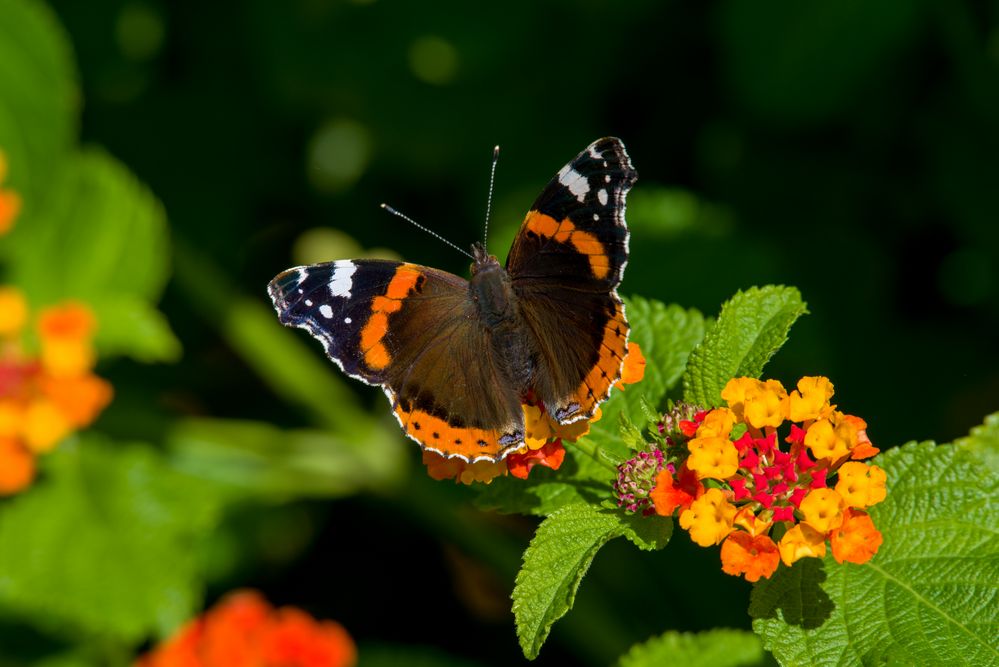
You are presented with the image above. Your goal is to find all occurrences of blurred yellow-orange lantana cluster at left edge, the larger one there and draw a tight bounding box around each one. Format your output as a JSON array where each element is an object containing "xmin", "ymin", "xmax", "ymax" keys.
[{"xmin": 0, "ymin": 287, "xmax": 112, "ymax": 496}]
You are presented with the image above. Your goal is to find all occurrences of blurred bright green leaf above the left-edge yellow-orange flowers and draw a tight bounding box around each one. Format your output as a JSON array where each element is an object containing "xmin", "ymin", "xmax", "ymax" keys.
[{"xmin": 10, "ymin": 149, "xmax": 180, "ymax": 361}]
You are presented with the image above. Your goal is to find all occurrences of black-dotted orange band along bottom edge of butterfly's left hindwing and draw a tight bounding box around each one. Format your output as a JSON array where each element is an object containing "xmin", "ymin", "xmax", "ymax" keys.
[{"xmin": 395, "ymin": 405, "xmax": 523, "ymax": 461}]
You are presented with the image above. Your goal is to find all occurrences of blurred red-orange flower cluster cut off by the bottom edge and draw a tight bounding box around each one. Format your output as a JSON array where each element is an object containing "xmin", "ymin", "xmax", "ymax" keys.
[{"xmin": 135, "ymin": 591, "xmax": 357, "ymax": 667}]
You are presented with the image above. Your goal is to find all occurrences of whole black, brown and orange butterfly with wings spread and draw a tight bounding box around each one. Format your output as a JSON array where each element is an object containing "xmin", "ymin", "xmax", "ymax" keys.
[{"xmin": 268, "ymin": 137, "xmax": 638, "ymax": 462}]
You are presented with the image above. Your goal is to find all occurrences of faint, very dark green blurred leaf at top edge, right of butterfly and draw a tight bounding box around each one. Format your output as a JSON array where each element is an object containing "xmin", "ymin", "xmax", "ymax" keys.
[{"xmin": 719, "ymin": 0, "xmax": 926, "ymax": 122}]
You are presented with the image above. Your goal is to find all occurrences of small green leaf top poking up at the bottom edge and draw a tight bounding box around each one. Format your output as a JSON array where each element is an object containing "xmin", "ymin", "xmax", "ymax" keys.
[{"xmin": 618, "ymin": 630, "xmax": 767, "ymax": 667}]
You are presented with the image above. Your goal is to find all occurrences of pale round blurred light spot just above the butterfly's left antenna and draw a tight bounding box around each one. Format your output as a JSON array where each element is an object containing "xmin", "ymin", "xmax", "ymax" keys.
[{"xmin": 306, "ymin": 119, "xmax": 371, "ymax": 193}]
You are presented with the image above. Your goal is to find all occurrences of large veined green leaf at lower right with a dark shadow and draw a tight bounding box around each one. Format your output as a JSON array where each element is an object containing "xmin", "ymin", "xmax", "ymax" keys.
[{"xmin": 749, "ymin": 414, "xmax": 999, "ymax": 665}]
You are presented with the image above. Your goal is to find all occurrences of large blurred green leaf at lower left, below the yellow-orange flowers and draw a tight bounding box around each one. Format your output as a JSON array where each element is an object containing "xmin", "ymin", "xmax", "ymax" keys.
[{"xmin": 0, "ymin": 435, "xmax": 218, "ymax": 643}]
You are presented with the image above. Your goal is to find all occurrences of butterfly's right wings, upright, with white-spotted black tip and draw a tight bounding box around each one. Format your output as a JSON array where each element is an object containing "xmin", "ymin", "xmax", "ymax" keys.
[{"xmin": 506, "ymin": 137, "xmax": 638, "ymax": 423}]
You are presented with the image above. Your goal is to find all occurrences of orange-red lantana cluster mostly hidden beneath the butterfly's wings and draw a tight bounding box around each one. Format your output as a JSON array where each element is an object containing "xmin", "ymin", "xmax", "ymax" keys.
[{"xmin": 423, "ymin": 342, "xmax": 645, "ymax": 484}]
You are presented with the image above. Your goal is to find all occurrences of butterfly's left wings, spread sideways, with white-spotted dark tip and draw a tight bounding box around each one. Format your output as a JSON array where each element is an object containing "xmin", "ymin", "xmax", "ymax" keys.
[{"xmin": 268, "ymin": 260, "xmax": 524, "ymax": 461}]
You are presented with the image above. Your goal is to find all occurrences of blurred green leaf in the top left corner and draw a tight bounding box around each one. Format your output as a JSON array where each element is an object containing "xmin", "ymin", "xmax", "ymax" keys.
[{"xmin": 0, "ymin": 0, "xmax": 80, "ymax": 210}]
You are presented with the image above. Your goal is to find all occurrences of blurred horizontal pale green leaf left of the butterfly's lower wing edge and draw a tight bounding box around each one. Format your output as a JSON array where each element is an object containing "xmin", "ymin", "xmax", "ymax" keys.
[{"xmin": 168, "ymin": 419, "xmax": 408, "ymax": 501}]
